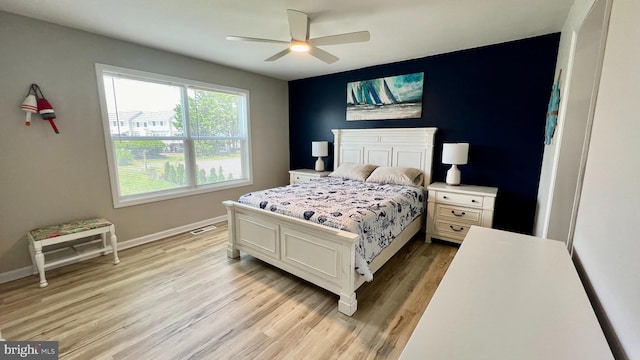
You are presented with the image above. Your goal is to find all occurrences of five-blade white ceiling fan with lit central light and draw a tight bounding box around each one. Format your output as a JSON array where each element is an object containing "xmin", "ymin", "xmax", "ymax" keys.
[{"xmin": 227, "ymin": 9, "xmax": 369, "ymax": 64}]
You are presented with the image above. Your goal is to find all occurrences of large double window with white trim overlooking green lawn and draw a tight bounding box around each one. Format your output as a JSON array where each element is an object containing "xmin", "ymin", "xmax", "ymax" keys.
[{"xmin": 96, "ymin": 64, "xmax": 252, "ymax": 207}]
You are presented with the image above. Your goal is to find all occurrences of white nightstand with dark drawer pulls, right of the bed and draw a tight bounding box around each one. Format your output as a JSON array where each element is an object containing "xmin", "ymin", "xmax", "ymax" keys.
[{"xmin": 426, "ymin": 183, "xmax": 498, "ymax": 244}]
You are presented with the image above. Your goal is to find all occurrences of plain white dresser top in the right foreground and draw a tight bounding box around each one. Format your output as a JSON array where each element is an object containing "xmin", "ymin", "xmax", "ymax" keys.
[{"xmin": 400, "ymin": 226, "xmax": 613, "ymax": 360}]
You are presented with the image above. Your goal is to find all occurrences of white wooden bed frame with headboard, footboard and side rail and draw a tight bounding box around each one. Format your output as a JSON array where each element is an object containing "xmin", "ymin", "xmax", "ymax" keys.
[{"xmin": 224, "ymin": 128, "xmax": 436, "ymax": 316}]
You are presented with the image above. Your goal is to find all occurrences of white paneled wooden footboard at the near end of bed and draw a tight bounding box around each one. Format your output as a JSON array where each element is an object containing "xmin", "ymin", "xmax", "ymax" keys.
[{"xmin": 224, "ymin": 201, "xmax": 359, "ymax": 316}]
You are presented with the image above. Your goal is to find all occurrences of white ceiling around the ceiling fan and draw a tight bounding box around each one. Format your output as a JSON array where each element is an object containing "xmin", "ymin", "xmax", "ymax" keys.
[{"xmin": 0, "ymin": 0, "xmax": 574, "ymax": 80}]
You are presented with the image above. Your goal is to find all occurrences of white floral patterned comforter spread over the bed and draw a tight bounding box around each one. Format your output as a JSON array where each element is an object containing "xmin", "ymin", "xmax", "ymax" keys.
[{"xmin": 239, "ymin": 178, "xmax": 426, "ymax": 281}]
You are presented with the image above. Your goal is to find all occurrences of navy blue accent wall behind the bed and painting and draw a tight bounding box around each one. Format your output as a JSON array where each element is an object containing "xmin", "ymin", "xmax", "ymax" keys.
[{"xmin": 289, "ymin": 33, "xmax": 560, "ymax": 234}]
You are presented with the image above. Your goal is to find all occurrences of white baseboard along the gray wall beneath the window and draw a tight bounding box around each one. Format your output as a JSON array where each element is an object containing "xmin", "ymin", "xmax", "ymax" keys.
[{"xmin": 0, "ymin": 215, "xmax": 227, "ymax": 284}]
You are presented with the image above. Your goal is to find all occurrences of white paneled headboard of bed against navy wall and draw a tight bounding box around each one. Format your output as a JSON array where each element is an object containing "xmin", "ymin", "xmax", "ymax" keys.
[{"xmin": 331, "ymin": 127, "xmax": 437, "ymax": 186}]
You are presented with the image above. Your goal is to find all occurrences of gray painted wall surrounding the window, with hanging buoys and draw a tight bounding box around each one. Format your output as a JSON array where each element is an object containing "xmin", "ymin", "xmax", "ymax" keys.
[{"xmin": 0, "ymin": 12, "xmax": 289, "ymax": 274}]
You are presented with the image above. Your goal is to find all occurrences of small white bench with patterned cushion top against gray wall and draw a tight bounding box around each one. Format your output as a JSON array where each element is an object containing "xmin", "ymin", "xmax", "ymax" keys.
[{"xmin": 27, "ymin": 218, "xmax": 120, "ymax": 287}]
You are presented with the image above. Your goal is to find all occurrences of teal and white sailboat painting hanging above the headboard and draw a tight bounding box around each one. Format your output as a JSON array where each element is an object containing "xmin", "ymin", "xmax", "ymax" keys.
[{"xmin": 347, "ymin": 72, "xmax": 424, "ymax": 121}]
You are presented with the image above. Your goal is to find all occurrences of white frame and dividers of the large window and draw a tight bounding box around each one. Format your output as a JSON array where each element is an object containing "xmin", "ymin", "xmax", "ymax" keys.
[{"xmin": 95, "ymin": 63, "xmax": 253, "ymax": 208}]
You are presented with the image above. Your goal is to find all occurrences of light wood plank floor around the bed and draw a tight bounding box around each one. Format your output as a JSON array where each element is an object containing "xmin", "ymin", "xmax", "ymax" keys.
[{"xmin": 0, "ymin": 223, "xmax": 457, "ymax": 360}]
